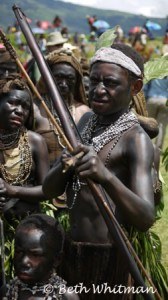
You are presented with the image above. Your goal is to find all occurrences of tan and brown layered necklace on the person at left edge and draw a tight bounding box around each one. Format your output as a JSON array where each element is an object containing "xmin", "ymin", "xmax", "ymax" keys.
[{"xmin": 0, "ymin": 129, "xmax": 32, "ymax": 186}]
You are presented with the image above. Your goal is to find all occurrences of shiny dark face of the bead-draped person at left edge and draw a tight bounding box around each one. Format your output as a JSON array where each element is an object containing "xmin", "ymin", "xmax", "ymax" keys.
[{"xmin": 0, "ymin": 90, "xmax": 30, "ymax": 130}]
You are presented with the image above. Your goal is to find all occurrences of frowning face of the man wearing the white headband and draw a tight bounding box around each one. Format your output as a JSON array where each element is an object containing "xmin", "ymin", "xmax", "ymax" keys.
[{"xmin": 89, "ymin": 62, "xmax": 131, "ymax": 115}]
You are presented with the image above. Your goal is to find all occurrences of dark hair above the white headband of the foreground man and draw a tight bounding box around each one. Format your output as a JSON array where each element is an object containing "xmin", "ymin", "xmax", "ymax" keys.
[{"xmin": 111, "ymin": 43, "xmax": 144, "ymax": 77}]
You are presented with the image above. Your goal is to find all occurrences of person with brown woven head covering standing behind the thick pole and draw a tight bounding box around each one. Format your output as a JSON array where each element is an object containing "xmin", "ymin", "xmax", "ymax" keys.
[{"xmin": 35, "ymin": 49, "xmax": 90, "ymax": 166}]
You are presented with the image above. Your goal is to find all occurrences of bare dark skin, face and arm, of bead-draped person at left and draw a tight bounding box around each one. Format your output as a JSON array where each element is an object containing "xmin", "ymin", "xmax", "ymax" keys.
[{"xmin": 0, "ymin": 89, "xmax": 49, "ymax": 214}]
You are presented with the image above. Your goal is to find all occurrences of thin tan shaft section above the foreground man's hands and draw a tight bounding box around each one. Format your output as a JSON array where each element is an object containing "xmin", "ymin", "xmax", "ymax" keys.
[{"xmin": 0, "ymin": 29, "xmax": 73, "ymax": 151}]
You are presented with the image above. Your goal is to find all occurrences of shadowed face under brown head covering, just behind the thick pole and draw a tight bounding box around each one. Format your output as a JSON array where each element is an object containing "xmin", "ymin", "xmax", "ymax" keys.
[{"xmin": 51, "ymin": 63, "xmax": 77, "ymax": 100}]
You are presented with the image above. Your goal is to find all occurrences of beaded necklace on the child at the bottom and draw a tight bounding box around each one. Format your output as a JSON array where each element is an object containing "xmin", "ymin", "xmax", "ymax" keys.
[{"xmin": 3, "ymin": 272, "xmax": 66, "ymax": 300}]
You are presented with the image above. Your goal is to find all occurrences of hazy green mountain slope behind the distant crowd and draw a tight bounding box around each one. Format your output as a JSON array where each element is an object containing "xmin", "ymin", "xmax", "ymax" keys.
[{"xmin": 0, "ymin": 0, "xmax": 167, "ymax": 36}]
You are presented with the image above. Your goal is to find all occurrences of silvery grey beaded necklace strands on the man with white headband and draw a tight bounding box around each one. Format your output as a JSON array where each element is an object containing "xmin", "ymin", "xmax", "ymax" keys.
[{"xmin": 68, "ymin": 111, "xmax": 139, "ymax": 209}]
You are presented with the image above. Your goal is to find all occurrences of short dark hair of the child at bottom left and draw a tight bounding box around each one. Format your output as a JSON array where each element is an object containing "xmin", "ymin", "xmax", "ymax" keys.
[{"xmin": 16, "ymin": 214, "xmax": 64, "ymax": 257}]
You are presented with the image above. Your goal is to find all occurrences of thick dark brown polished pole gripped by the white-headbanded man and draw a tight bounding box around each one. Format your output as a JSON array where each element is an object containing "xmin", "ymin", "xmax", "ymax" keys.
[{"xmin": 13, "ymin": 5, "xmax": 161, "ymax": 300}]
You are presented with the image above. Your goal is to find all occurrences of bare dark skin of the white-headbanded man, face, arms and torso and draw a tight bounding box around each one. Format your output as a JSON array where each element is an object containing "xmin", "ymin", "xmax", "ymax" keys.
[{"xmin": 43, "ymin": 62, "xmax": 154, "ymax": 244}]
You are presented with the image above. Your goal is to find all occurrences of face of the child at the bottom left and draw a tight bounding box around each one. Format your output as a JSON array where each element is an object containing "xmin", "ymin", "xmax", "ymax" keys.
[{"xmin": 14, "ymin": 228, "xmax": 54, "ymax": 284}]
